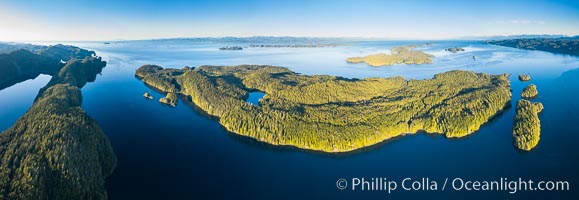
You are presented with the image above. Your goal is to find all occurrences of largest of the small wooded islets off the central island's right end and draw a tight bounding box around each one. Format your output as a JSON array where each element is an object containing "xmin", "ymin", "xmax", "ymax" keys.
[{"xmin": 513, "ymin": 99, "xmax": 543, "ymax": 151}]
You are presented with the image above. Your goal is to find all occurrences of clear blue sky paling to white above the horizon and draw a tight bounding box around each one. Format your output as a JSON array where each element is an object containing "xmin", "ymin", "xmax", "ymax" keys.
[{"xmin": 0, "ymin": 0, "xmax": 579, "ymax": 41}]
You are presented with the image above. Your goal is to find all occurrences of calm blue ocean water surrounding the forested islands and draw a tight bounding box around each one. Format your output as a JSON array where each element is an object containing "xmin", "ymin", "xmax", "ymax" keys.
[{"xmin": 0, "ymin": 40, "xmax": 579, "ymax": 199}]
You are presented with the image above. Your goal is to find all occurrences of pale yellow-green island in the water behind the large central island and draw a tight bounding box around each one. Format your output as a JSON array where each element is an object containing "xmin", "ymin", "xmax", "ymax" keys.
[{"xmin": 346, "ymin": 45, "xmax": 434, "ymax": 67}]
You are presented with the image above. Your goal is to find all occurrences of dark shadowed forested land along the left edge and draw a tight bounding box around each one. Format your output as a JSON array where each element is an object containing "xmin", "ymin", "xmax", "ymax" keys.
[{"xmin": 0, "ymin": 45, "xmax": 116, "ymax": 199}]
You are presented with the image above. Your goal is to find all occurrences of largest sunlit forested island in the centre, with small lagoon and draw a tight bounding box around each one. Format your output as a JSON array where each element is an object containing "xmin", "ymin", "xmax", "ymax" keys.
[{"xmin": 135, "ymin": 65, "xmax": 511, "ymax": 152}]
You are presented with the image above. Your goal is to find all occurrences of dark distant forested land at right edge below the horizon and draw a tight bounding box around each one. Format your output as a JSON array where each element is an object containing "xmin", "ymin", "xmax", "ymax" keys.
[{"xmin": 486, "ymin": 37, "xmax": 579, "ymax": 56}]
